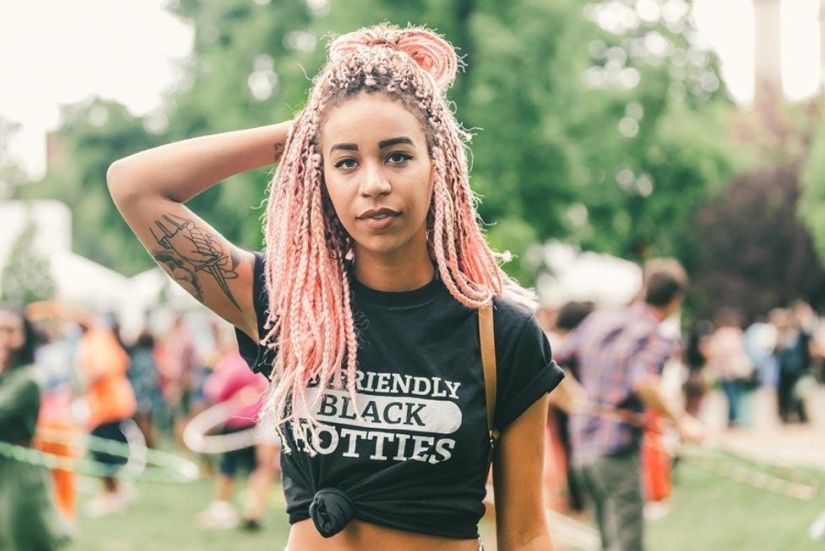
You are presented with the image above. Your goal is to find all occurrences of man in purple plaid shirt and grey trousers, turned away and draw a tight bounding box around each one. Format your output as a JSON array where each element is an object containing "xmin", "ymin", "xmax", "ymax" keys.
[{"xmin": 555, "ymin": 259, "xmax": 704, "ymax": 551}]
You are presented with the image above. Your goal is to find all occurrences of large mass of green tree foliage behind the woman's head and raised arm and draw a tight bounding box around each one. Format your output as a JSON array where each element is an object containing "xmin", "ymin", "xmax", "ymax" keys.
[{"xmin": 30, "ymin": 0, "xmax": 737, "ymax": 283}]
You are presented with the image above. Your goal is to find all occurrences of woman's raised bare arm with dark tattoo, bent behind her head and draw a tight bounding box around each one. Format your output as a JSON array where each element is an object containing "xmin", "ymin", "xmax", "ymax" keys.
[{"xmin": 106, "ymin": 121, "xmax": 292, "ymax": 340}]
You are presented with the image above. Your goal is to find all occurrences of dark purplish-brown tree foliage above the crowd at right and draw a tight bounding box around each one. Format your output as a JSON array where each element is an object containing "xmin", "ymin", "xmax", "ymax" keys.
[{"xmin": 691, "ymin": 166, "xmax": 825, "ymax": 319}]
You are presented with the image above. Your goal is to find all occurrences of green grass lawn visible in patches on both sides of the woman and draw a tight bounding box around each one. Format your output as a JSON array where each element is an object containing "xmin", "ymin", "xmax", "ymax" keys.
[{"xmin": 62, "ymin": 461, "xmax": 825, "ymax": 551}]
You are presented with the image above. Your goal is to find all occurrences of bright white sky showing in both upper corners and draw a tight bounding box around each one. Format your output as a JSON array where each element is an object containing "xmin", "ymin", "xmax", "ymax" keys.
[{"xmin": 0, "ymin": 0, "xmax": 821, "ymax": 178}]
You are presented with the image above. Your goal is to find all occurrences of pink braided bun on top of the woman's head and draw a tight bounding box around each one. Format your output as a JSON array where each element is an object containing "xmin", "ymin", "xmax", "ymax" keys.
[{"xmin": 329, "ymin": 24, "xmax": 459, "ymax": 90}]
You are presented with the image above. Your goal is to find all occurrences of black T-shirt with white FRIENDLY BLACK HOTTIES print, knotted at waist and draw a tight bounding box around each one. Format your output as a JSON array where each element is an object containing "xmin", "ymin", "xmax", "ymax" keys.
[{"xmin": 237, "ymin": 255, "xmax": 563, "ymax": 538}]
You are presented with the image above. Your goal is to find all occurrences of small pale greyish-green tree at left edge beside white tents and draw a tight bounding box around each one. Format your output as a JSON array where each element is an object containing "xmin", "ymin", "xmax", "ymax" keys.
[{"xmin": 0, "ymin": 216, "xmax": 56, "ymax": 305}]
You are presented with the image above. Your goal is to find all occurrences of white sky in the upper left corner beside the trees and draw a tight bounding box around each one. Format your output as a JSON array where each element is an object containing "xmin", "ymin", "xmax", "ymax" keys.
[{"xmin": 0, "ymin": 0, "xmax": 194, "ymax": 177}]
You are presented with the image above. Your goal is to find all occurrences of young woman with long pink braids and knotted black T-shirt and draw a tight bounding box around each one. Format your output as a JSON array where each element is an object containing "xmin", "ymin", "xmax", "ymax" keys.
[{"xmin": 108, "ymin": 25, "xmax": 562, "ymax": 551}]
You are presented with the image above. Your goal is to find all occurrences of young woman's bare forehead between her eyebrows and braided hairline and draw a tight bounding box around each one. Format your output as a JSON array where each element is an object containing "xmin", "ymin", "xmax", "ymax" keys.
[{"xmin": 321, "ymin": 93, "xmax": 426, "ymax": 149}]
